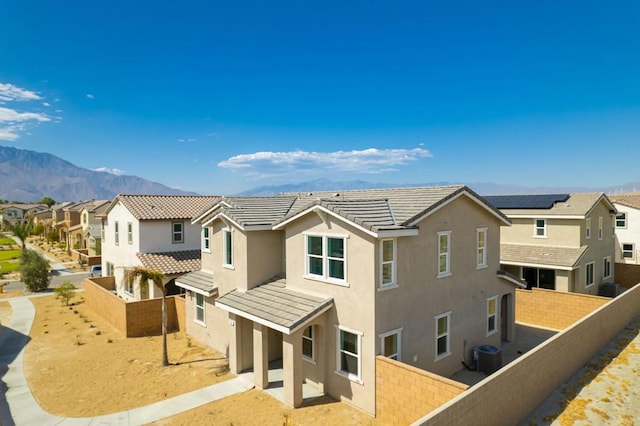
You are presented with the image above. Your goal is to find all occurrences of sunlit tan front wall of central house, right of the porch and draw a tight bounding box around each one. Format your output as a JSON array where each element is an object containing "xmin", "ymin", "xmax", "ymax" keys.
[{"xmin": 286, "ymin": 213, "xmax": 377, "ymax": 414}]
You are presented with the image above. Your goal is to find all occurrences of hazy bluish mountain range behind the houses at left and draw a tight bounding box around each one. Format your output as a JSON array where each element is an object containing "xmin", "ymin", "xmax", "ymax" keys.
[{"xmin": 0, "ymin": 146, "xmax": 193, "ymax": 202}]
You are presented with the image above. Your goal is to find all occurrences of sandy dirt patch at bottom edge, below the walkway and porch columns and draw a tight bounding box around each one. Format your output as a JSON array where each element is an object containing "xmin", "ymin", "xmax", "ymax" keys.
[{"xmin": 151, "ymin": 389, "xmax": 381, "ymax": 426}]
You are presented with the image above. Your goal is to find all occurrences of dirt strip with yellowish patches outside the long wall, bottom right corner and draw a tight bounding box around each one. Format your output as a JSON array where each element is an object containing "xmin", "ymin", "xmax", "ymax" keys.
[{"xmin": 521, "ymin": 318, "xmax": 640, "ymax": 426}]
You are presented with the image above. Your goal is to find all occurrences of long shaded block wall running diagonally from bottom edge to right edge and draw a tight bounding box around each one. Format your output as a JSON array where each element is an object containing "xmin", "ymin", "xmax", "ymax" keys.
[{"xmin": 413, "ymin": 286, "xmax": 640, "ymax": 426}]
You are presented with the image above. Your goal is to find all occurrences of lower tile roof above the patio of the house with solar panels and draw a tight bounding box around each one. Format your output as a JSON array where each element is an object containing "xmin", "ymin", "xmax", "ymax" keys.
[{"xmin": 500, "ymin": 243, "xmax": 588, "ymax": 269}]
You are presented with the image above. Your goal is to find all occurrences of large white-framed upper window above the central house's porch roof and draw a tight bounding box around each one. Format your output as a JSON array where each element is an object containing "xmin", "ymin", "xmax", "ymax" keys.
[{"xmin": 305, "ymin": 235, "xmax": 347, "ymax": 284}]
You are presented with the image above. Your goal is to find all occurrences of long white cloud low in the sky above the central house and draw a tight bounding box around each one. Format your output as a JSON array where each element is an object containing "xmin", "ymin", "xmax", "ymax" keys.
[{"xmin": 218, "ymin": 148, "xmax": 431, "ymax": 178}]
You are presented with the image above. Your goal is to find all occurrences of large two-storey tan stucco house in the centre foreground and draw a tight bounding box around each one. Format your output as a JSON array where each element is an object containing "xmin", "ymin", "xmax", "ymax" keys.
[{"xmin": 176, "ymin": 186, "xmax": 524, "ymax": 414}]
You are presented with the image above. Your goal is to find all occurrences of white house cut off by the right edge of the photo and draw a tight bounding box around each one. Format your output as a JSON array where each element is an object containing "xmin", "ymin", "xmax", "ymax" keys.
[{"xmin": 609, "ymin": 192, "xmax": 640, "ymax": 286}]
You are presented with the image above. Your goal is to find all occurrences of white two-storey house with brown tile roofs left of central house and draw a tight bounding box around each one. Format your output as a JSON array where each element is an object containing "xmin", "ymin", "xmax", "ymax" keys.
[{"xmin": 101, "ymin": 195, "xmax": 217, "ymax": 300}]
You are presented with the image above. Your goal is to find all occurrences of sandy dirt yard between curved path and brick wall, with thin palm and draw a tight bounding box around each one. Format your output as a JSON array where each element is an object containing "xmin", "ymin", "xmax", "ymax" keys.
[{"xmin": 24, "ymin": 294, "xmax": 232, "ymax": 417}]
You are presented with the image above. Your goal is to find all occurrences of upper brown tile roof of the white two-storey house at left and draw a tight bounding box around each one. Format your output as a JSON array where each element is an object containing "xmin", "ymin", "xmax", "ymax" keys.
[{"xmin": 107, "ymin": 194, "xmax": 220, "ymax": 220}]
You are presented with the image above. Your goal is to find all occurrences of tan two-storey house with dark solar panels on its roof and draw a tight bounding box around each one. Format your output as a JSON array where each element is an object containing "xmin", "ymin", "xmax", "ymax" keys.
[{"xmin": 485, "ymin": 193, "xmax": 616, "ymax": 294}]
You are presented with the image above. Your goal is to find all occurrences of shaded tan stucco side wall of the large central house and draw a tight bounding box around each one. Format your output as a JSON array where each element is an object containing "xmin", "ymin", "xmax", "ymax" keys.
[{"xmin": 375, "ymin": 197, "xmax": 514, "ymax": 376}]
